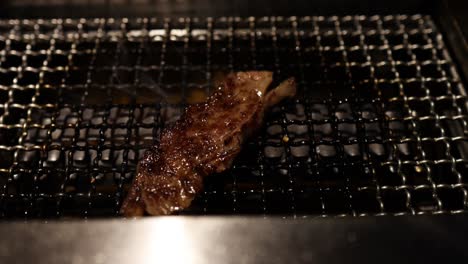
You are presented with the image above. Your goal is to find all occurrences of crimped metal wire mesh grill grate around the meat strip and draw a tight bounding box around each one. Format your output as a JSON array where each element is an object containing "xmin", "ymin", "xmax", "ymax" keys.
[{"xmin": 0, "ymin": 15, "xmax": 468, "ymax": 218}]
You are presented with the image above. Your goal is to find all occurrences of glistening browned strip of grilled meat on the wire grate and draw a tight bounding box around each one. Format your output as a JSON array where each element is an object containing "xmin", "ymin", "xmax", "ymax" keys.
[{"xmin": 121, "ymin": 71, "xmax": 296, "ymax": 216}]
